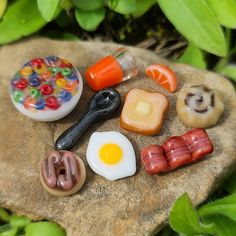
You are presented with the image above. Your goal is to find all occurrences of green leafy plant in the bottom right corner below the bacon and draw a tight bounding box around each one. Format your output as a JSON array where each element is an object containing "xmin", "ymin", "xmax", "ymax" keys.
[{"xmin": 159, "ymin": 171, "xmax": 236, "ymax": 236}]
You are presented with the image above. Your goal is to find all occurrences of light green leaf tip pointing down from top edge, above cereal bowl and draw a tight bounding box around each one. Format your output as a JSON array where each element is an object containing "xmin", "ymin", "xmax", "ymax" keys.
[{"xmin": 37, "ymin": 0, "xmax": 60, "ymax": 22}]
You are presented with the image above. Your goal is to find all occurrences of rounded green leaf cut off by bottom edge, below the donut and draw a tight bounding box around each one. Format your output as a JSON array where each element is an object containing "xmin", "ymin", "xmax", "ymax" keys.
[{"xmin": 25, "ymin": 222, "xmax": 66, "ymax": 236}]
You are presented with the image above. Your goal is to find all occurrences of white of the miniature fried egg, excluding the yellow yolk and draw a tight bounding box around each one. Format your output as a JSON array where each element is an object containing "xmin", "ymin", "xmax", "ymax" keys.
[{"xmin": 86, "ymin": 131, "xmax": 136, "ymax": 180}]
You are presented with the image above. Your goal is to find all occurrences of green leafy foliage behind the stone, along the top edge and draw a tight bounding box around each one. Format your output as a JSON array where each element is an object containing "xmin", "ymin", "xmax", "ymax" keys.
[{"xmin": 0, "ymin": 0, "xmax": 236, "ymax": 80}]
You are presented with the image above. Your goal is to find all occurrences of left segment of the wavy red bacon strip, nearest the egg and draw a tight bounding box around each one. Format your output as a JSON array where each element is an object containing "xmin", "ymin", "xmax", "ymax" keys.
[{"xmin": 141, "ymin": 145, "xmax": 169, "ymax": 175}]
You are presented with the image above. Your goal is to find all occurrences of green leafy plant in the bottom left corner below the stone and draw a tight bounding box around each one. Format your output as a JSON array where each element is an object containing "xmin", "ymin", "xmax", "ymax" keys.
[{"xmin": 0, "ymin": 208, "xmax": 66, "ymax": 236}]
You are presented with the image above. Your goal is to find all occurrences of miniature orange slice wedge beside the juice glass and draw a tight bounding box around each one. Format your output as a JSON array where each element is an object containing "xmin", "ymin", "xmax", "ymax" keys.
[{"xmin": 146, "ymin": 64, "xmax": 177, "ymax": 93}]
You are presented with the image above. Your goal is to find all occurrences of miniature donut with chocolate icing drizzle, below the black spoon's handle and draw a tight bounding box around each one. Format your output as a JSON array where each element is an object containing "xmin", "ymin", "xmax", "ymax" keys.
[{"xmin": 40, "ymin": 151, "xmax": 86, "ymax": 196}]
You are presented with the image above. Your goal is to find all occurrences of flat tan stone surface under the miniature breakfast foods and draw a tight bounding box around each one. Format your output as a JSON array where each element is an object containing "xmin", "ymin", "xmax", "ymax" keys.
[{"xmin": 0, "ymin": 39, "xmax": 236, "ymax": 236}]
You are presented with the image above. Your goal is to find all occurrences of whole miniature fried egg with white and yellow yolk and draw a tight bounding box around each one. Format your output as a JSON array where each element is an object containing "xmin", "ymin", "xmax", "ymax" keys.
[{"xmin": 86, "ymin": 131, "xmax": 136, "ymax": 180}]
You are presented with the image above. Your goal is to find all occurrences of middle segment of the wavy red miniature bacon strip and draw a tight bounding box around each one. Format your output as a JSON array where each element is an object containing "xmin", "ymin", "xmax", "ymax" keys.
[{"xmin": 162, "ymin": 136, "xmax": 192, "ymax": 170}]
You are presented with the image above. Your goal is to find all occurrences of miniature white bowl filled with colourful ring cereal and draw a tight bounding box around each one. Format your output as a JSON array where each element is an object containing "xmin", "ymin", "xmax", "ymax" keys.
[{"xmin": 10, "ymin": 56, "xmax": 83, "ymax": 121}]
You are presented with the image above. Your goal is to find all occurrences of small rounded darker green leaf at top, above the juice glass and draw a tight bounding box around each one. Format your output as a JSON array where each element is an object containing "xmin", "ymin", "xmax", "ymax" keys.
[{"xmin": 75, "ymin": 8, "xmax": 105, "ymax": 31}]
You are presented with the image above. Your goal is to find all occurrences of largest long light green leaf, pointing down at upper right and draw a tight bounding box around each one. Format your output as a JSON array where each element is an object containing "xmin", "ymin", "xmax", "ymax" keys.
[{"xmin": 157, "ymin": 0, "xmax": 227, "ymax": 56}]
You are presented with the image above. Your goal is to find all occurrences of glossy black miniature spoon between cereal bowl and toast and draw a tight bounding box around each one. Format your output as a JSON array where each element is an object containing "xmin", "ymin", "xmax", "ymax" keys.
[{"xmin": 55, "ymin": 88, "xmax": 121, "ymax": 150}]
